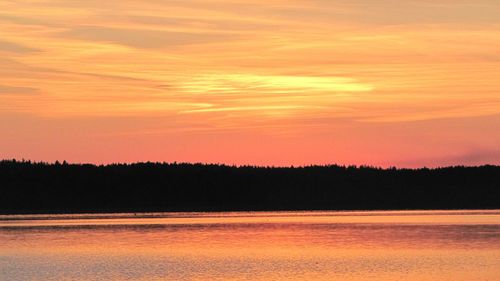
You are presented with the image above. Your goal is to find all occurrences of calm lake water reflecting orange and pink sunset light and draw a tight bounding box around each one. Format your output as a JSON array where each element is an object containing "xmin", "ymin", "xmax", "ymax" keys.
[{"xmin": 0, "ymin": 210, "xmax": 500, "ymax": 281}]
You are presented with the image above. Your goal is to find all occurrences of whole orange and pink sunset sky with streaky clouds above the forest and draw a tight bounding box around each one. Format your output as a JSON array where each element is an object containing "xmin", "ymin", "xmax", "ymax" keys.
[{"xmin": 0, "ymin": 0, "xmax": 500, "ymax": 167}]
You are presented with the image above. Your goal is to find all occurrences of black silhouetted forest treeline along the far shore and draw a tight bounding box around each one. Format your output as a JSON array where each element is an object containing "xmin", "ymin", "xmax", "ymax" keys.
[{"xmin": 0, "ymin": 160, "xmax": 500, "ymax": 213}]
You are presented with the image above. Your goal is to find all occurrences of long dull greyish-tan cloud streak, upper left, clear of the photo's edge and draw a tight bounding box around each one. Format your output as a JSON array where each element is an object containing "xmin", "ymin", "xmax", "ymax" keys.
[{"xmin": 60, "ymin": 26, "xmax": 236, "ymax": 49}]
